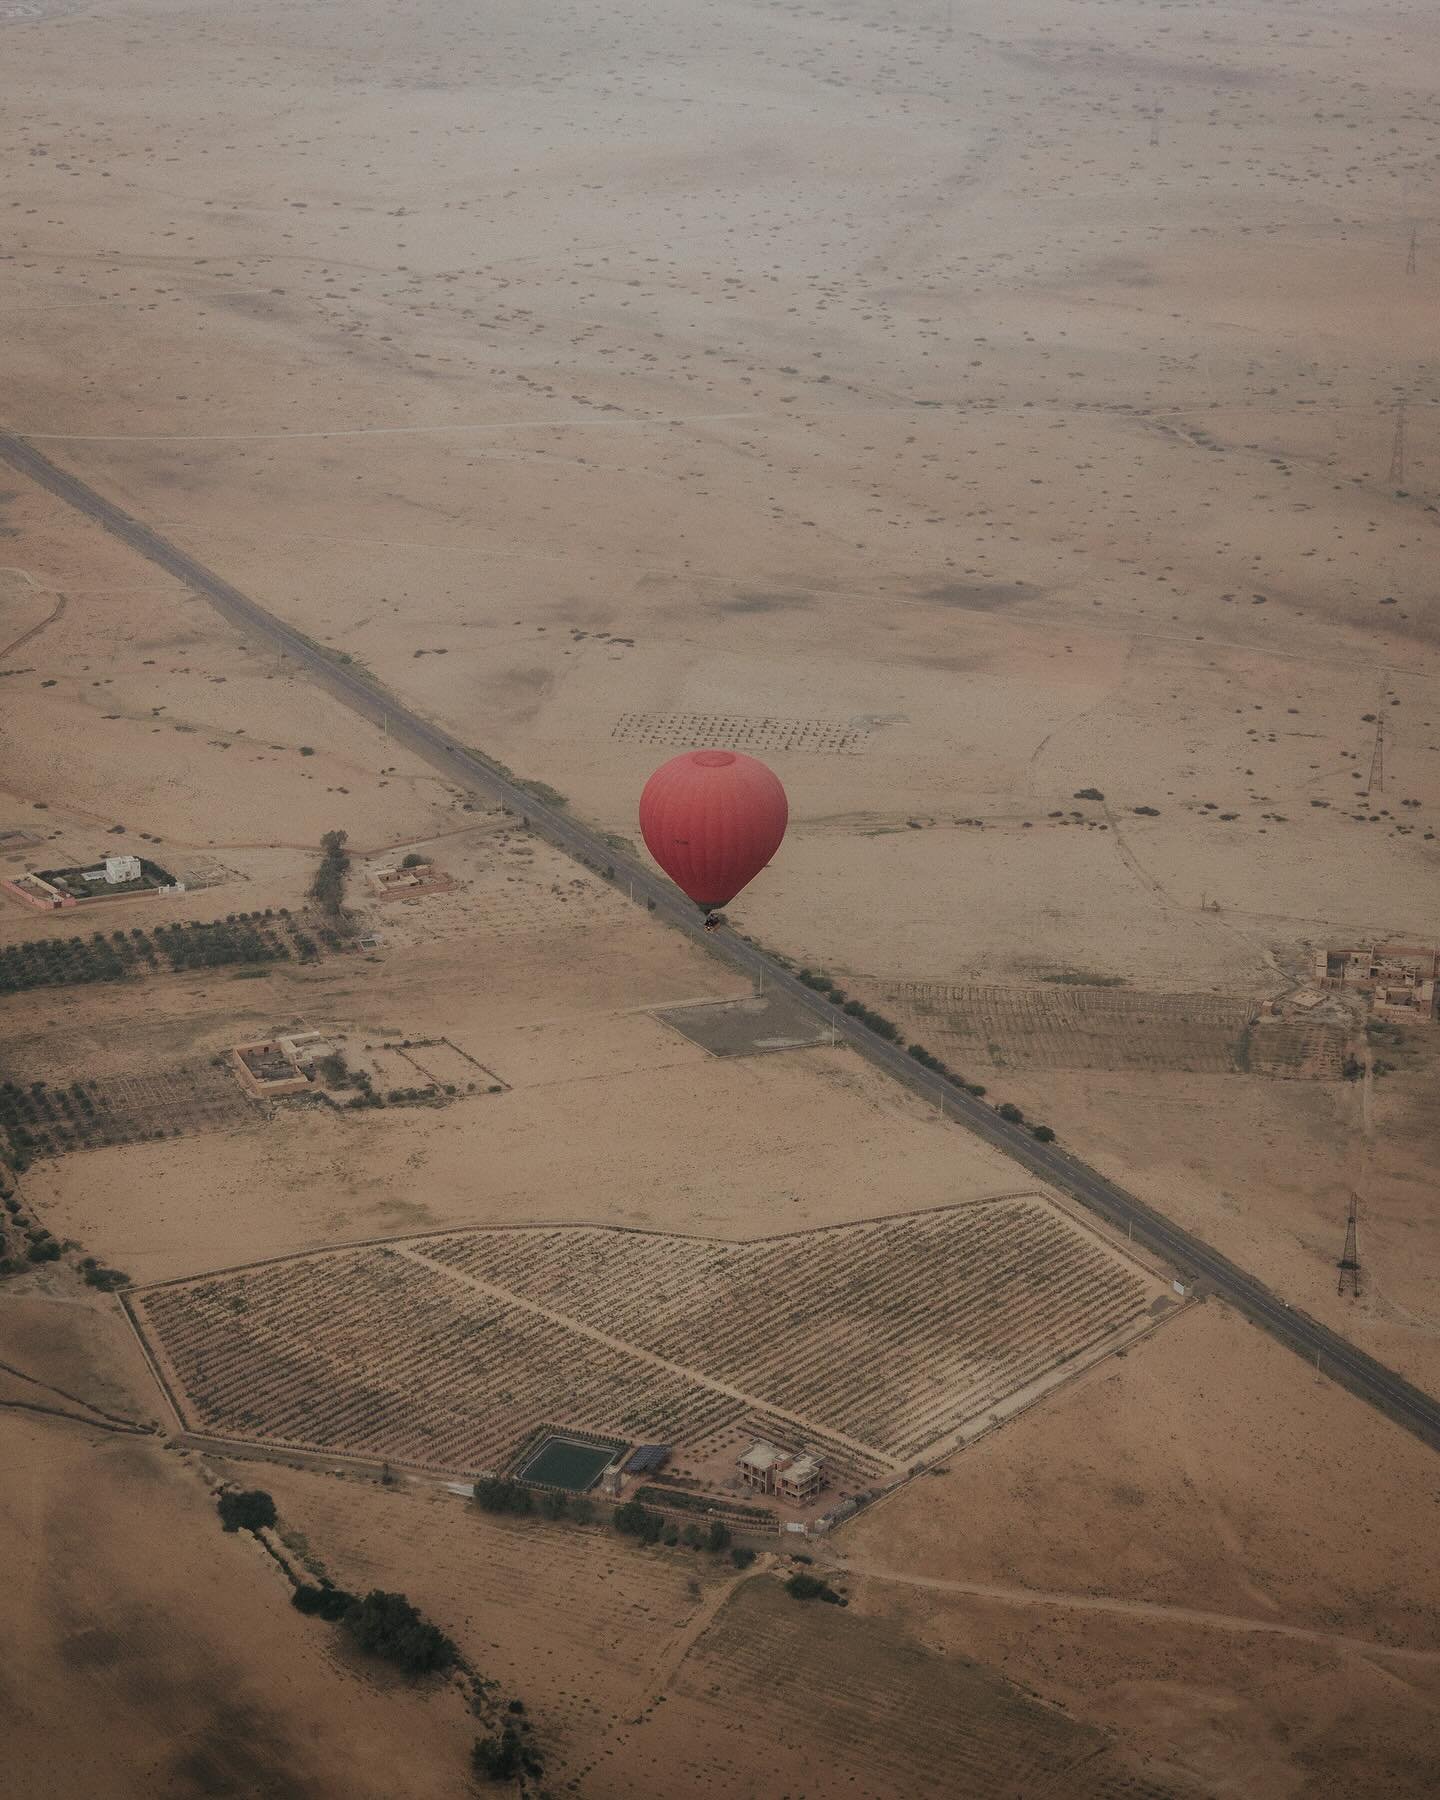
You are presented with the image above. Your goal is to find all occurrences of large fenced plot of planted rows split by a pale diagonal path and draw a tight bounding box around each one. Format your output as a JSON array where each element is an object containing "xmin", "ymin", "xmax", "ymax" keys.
[{"xmin": 133, "ymin": 1195, "xmax": 1170, "ymax": 1490}]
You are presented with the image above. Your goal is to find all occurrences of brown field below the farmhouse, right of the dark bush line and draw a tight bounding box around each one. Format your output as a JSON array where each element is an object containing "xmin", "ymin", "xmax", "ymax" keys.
[{"xmin": 244, "ymin": 1471, "xmax": 1193, "ymax": 1800}]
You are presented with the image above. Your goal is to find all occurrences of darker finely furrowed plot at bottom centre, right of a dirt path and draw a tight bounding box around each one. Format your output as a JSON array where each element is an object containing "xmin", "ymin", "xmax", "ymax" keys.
[{"xmin": 648, "ymin": 1580, "xmax": 1159, "ymax": 1800}]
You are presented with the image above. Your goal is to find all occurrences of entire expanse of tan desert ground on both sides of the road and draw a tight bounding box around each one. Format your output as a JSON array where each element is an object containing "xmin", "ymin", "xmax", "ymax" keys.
[{"xmin": 0, "ymin": 0, "xmax": 1440, "ymax": 1800}]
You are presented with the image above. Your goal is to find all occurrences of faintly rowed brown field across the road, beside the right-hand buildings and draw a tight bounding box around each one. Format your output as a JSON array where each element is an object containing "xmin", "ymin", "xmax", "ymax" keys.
[{"xmin": 878, "ymin": 981, "xmax": 1255, "ymax": 1075}]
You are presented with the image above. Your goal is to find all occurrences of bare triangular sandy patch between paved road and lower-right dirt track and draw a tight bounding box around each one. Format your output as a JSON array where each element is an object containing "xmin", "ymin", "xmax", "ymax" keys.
[{"xmin": 837, "ymin": 1303, "xmax": 1440, "ymax": 1649}]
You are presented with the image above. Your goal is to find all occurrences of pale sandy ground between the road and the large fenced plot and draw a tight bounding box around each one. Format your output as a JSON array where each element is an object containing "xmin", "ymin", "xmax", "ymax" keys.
[{"xmin": 14, "ymin": 846, "xmax": 1031, "ymax": 1280}]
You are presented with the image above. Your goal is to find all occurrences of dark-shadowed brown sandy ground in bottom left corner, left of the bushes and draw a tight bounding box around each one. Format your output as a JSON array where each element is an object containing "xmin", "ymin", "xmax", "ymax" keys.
[{"xmin": 0, "ymin": 1413, "xmax": 472, "ymax": 1800}]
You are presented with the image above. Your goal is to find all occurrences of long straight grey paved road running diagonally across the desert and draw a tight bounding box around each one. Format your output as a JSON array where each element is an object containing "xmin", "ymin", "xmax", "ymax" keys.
[{"xmin": 0, "ymin": 436, "xmax": 1440, "ymax": 1449}]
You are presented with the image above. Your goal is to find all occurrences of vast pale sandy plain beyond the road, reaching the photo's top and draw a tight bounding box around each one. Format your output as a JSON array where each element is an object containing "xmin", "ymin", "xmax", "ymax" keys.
[{"xmin": 9, "ymin": 0, "xmax": 1440, "ymax": 985}]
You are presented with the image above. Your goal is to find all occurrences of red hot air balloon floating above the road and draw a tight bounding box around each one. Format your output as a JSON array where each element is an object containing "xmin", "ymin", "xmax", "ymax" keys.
[{"xmin": 641, "ymin": 751, "xmax": 790, "ymax": 913}]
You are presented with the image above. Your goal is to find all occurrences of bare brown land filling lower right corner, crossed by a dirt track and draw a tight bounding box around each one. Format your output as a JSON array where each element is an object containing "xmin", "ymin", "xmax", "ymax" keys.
[{"xmin": 832, "ymin": 1305, "xmax": 1440, "ymax": 1800}]
